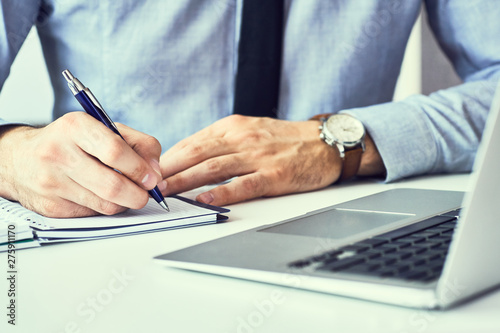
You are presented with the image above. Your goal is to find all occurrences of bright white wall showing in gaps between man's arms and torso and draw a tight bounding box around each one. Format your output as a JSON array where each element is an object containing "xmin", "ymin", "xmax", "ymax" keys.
[{"xmin": 0, "ymin": 19, "xmax": 421, "ymax": 124}]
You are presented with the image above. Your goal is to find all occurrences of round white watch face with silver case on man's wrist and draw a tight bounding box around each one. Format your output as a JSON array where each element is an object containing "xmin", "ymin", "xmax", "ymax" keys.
[{"xmin": 324, "ymin": 114, "xmax": 365, "ymax": 146}]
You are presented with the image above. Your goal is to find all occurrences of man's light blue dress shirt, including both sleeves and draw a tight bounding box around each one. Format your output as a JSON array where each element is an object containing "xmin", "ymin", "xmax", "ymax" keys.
[{"xmin": 0, "ymin": 0, "xmax": 500, "ymax": 181}]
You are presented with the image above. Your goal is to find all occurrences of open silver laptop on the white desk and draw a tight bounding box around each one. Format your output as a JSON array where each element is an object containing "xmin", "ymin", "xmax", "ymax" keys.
[{"xmin": 155, "ymin": 86, "xmax": 500, "ymax": 309}]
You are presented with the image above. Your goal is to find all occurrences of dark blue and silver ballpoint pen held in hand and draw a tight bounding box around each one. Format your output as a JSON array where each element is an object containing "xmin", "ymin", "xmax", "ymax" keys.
[{"xmin": 62, "ymin": 69, "xmax": 170, "ymax": 211}]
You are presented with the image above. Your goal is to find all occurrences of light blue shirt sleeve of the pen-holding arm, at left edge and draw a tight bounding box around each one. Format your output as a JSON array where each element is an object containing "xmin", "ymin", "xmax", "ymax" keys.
[{"xmin": 0, "ymin": 0, "xmax": 41, "ymax": 126}]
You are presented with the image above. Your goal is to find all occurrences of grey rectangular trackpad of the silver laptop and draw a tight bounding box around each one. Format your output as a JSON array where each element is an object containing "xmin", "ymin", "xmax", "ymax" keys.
[{"xmin": 259, "ymin": 209, "xmax": 414, "ymax": 239}]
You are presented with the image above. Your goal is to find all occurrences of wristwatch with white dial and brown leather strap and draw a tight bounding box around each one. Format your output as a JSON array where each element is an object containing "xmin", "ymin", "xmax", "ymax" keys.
[{"xmin": 311, "ymin": 114, "xmax": 366, "ymax": 181}]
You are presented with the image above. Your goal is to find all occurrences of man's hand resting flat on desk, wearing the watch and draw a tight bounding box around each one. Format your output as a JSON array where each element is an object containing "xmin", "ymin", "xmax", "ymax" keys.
[{"xmin": 159, "ymin": 115, "xmax": 341, "ymax": 205}]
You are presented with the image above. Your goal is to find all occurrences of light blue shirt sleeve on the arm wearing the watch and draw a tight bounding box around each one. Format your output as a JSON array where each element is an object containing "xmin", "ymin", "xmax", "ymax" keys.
[{"xmin": 344, "ymin": 0, "xmax": 500, "ymax": 182}]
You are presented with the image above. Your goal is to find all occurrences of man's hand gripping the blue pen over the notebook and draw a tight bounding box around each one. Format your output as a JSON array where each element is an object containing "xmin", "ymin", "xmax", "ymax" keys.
[{"xmin": 0, "ymin": 112, "xmax": 161, "ymax": 217}]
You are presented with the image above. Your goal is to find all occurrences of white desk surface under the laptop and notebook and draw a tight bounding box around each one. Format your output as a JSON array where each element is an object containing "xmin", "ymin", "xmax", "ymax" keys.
[{"xmin": 0, "ymin": 175, "xmax": 500, "ymax": 333}]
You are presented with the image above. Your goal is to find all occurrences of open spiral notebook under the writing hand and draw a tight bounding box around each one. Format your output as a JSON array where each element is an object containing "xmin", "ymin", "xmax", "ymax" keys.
[{"xmin": 0, "ymin": 196, "xmax": 229, "ymax": 252}]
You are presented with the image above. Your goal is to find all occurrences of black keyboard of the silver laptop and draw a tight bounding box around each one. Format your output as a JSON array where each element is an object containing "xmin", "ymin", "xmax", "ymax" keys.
[{"xmin": 289, "ymin": 210, "xmax": 459, "ymax": 282}]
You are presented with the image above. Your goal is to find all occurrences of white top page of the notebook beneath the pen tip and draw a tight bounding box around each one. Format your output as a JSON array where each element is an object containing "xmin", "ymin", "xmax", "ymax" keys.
[{"xmin": 31, "ymin": 197, "xmax": 217, "ymax": 230}]
